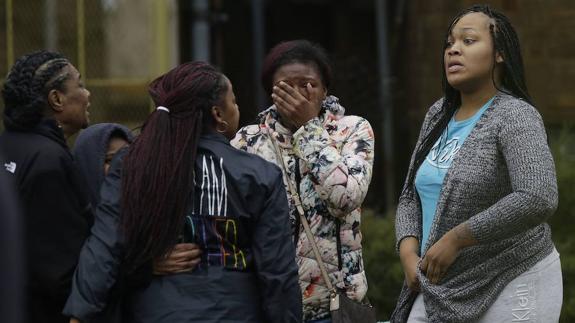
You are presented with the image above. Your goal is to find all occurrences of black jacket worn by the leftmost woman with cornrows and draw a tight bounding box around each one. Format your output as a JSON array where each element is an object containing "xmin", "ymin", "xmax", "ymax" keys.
[{"xmin": 0, "ymin": 119, "xmax": 93, "ymax": 322}]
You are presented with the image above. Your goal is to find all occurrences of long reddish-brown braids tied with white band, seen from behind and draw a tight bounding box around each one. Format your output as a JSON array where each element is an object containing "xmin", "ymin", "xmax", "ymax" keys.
[{"xmin": 121, "ymin": 62, "xmax": 227, "ymax": 271}]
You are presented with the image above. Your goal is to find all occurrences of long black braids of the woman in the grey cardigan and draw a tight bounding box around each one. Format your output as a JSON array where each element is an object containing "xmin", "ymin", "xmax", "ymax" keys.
[{"xmin": 403, "ymin": 5, "xmax": 532, "ymax": 193}]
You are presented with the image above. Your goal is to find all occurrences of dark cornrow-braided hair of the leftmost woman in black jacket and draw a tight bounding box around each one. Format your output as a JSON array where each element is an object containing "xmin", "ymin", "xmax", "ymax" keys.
[{"xmin": 2, "ymin": 50, "xmax": 70, "ymax": 131}]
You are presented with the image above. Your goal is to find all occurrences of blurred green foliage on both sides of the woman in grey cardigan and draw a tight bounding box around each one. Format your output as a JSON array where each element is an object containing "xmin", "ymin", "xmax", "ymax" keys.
[{"xmin": 361, "ymin": 126, "xmax": 575, "ymax": 323}]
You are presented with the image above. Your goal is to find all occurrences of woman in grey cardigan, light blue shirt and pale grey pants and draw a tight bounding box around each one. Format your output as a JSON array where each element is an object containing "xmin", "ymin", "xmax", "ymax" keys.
[{"xmin": 391, "ymin": 5, "xmax": 562, "ymax": 323}]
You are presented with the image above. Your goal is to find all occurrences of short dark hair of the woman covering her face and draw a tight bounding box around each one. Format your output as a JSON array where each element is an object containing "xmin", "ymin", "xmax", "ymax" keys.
[{"xmin": 262, "ymin": 39, "xmax": 332, "ymax": 94}]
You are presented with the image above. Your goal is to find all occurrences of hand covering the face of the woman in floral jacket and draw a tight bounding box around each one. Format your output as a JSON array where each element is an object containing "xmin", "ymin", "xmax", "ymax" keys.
[{"xmin": 272, "ymin": 81, "xmax": 322, "ymax": 130}]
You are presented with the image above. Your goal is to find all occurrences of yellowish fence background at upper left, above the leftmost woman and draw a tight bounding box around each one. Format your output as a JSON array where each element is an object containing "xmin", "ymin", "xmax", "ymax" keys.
[{"xmin": 0, "ymin": 0, "xmax": 177, "ymax": 136}]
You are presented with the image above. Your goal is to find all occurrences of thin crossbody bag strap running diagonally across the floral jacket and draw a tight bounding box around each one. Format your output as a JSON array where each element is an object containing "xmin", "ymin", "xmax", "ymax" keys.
[{"xmin": 268, "ymin": 130, "xmax": 336, "ymax": 294}]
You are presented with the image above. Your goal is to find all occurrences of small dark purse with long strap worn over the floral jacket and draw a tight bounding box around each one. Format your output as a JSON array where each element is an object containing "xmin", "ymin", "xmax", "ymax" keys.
[{"xmin": 268, "ymin": 131, "xmax": 377, "ymax": 323}]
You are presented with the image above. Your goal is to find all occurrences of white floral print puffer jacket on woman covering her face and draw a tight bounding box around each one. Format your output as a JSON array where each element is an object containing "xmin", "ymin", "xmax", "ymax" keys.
[{"xmin": 232, "ymin": 96, "xmax": 374, "ymax": 321}]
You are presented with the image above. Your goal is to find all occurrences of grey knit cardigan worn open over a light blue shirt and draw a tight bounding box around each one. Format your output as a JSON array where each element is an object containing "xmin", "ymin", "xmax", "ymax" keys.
[{"xmin": 391, "ymin": 92, "xmax": 558, "ymax": 323}]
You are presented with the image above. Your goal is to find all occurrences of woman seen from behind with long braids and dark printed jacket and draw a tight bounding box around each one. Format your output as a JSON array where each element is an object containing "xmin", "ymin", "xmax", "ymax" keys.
[{"xmin": 64, "ymin": 62, "xmax": 301, "ymax": 323}]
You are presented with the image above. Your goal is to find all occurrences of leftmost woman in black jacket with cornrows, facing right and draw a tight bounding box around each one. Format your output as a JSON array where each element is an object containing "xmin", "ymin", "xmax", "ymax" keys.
[{"xmin": 0, "ymin": 51, "xmax": 92, "ymax": 322}]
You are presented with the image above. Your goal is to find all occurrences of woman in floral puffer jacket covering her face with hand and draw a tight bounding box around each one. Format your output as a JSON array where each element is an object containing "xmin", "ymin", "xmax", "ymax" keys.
[{"xmin": 232, "ymin": 40, "xmax": 374, "ymax": 322}]
